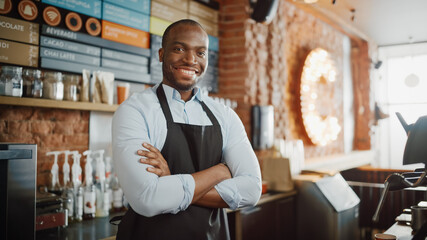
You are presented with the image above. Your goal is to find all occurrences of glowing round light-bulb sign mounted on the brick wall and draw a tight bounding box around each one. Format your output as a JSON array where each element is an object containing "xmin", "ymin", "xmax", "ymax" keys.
[{"xmin": 300, "ymin": 48, "xmax": 341, "ymax": 146}]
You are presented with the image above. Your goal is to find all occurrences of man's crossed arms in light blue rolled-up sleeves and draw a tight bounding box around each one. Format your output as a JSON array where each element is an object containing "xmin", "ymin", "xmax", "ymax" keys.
[{"xmin": 112, "ymin": 94, "xmax": 261, "ymax": 217}]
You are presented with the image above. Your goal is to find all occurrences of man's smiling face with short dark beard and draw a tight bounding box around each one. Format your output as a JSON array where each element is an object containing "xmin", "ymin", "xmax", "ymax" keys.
[{"xmin": 159, "ymin": 24, "xmax": 209, "ymax": 91}]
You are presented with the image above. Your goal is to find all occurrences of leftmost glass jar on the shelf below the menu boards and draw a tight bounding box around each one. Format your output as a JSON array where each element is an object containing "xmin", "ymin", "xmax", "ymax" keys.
[{"xmin": 0, "ymin": 66, "xmax": 22, "ymax": 97}]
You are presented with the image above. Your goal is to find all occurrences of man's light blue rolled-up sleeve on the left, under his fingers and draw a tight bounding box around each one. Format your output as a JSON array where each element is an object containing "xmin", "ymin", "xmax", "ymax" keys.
[{"xmin": 112, "ymin": 100, "xmax": 195, "ymax": 217}]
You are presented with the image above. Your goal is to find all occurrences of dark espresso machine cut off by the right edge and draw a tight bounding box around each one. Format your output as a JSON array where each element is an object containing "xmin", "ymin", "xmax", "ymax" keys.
[{"xmin": 372, "ymin": 113, "xmax": 427, "ymax": 240}]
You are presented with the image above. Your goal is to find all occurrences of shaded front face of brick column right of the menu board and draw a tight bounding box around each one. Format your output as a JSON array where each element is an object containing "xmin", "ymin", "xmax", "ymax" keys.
[{"xmin": 218, "ymin": 0, "xmax": 252, "ymax": 134}]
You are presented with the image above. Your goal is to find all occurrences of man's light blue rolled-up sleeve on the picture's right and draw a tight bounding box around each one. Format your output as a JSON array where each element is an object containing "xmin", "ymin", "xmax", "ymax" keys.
[{"xmin": 215, "ymin": 111, "xmax": 261, "ymax": 209}]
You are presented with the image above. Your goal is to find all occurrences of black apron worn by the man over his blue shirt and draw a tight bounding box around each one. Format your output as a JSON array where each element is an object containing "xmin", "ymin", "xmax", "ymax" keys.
[{"xmin": 117, "ymin": 84, "xmax": 230, "ymax": 240}]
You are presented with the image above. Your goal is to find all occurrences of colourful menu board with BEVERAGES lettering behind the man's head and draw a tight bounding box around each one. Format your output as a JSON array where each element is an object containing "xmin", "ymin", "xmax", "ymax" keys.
[{"xmin": 0, "ymin": 0, "xmax": 219, "ymax": 89}]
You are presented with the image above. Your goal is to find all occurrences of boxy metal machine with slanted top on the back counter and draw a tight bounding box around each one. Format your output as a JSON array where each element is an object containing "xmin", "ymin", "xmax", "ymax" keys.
[{"xmin": 294, "ymin": 173, "xmax": 360, "ymax": 240}]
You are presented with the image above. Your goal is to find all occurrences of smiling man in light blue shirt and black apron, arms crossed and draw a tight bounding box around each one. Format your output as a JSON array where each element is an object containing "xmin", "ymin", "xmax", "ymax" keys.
[{"xmin": 112, "ymin": 19, "xmax": 261, "ymax": 240}]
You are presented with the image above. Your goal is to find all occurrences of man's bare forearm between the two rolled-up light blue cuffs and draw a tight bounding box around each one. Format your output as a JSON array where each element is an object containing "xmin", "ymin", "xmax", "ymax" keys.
[{"xmin": 191, "ymin": 163, "xmax": 231, "ymax": 204}]
